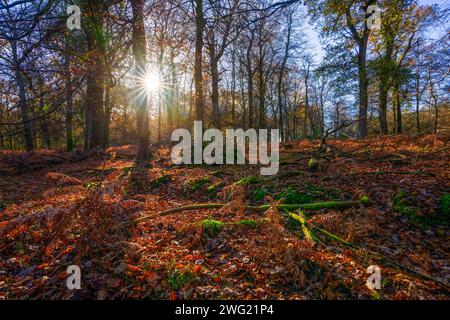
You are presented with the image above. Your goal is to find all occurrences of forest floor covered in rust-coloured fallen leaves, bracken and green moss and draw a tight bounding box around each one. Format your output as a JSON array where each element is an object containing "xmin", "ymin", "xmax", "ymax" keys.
[{"xmin": 0, "ymin": 135, "xmax": 450, "ymax": 299}]
